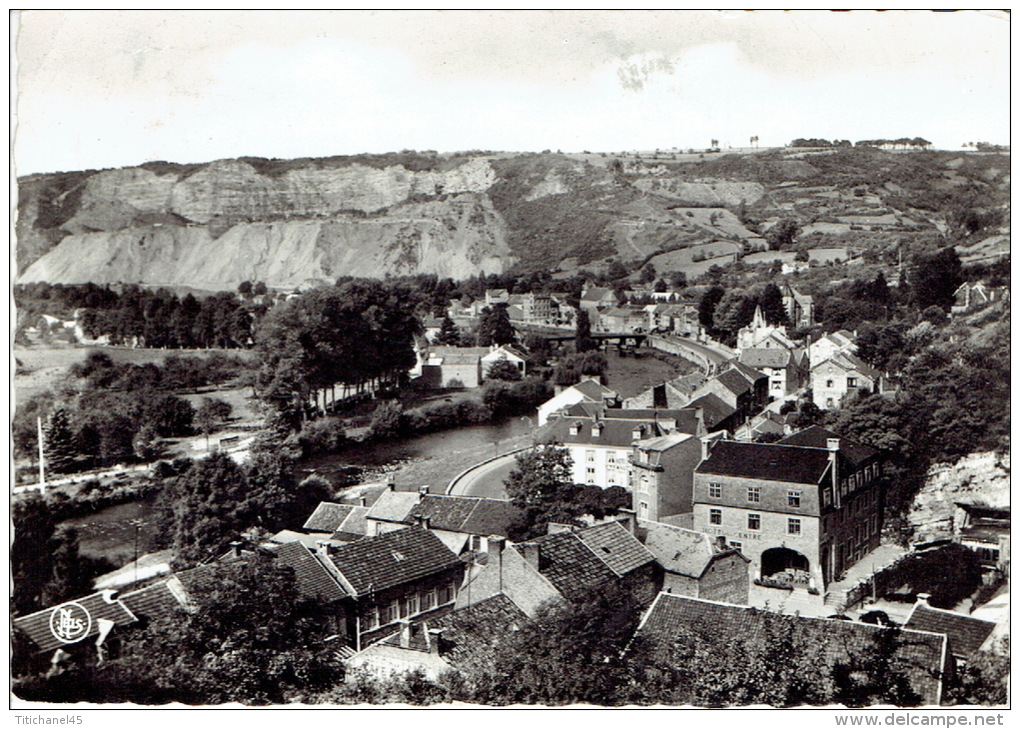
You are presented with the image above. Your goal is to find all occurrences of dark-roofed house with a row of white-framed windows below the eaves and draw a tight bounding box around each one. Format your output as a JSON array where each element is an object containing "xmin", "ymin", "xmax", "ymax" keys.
[{"xmin": 324, "ymin": 526, "xmax": 464, "ymax": 650}]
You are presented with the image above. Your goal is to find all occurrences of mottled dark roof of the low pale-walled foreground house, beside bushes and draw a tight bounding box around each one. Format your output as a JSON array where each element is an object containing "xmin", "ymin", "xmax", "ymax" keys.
[{"xmin": 428, "ymin": 592, "xmax": 527, "ymax": 670}]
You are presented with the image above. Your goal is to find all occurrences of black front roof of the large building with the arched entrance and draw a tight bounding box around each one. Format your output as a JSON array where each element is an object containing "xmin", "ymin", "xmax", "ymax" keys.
[{"xmin": 695, "ymin": 440, "xmax": 829, "ymax": 483}]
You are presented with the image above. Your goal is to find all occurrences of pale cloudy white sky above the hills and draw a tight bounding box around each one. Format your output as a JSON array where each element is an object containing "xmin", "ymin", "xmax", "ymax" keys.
[{"xmin": 9, "ymin": 10, "xmax": 1010, "ymax": 175}]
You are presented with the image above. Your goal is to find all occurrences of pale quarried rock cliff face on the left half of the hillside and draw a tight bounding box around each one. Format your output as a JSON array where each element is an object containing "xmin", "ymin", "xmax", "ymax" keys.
[{"xmin": 18, "ymin": 158, "xmax": 513, "ymax": 289}]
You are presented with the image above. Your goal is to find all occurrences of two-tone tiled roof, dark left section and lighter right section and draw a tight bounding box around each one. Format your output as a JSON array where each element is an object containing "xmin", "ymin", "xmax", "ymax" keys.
[{"xmin": 514, "ymin": 522, "xmax": 655, "ymax": 600}]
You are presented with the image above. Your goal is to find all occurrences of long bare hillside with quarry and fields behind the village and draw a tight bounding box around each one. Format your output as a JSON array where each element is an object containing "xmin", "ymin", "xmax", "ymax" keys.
[{"xmin": 16, "ymin": 149, "xmax": 1010, "ymax": 290}]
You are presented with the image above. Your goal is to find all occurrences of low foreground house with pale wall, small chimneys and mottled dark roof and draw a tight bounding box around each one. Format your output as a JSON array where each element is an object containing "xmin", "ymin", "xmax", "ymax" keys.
[{"xmin": 347, "ymin": 593, "xmax": 528, "ymax": 680}]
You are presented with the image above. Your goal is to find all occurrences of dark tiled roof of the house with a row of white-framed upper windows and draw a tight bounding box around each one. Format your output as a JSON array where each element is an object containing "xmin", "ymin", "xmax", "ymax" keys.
[{"xmin": 329, "ymin": 526, "xmax": 462, "ymax": 595}]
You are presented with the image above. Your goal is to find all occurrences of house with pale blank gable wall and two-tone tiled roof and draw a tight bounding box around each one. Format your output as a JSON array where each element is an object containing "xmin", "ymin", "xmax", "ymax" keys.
[{"xmin": 457, "ymin": 520, "xmax": 662, "ymax": 616}]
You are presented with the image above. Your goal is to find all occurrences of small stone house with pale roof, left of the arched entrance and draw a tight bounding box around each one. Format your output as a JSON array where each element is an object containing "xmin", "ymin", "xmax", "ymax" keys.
[{"xmin": 638, "ymin": 519, "xmax": 751, "ymax": 605}]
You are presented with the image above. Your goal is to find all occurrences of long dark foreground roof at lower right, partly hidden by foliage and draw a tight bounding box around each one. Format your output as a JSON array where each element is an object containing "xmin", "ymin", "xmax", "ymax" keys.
[{"xmin": 636, "ymin": 592, "xmax": 954, "ymax": 706}]
